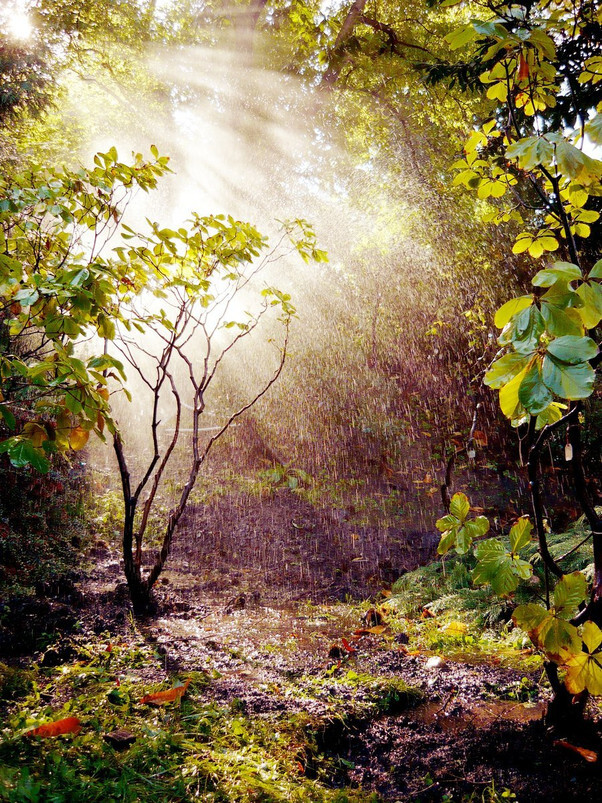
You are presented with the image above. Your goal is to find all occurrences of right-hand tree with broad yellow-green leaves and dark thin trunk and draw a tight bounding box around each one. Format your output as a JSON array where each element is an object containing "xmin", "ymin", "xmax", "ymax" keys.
[{"xmin": 430, "ymin": 0, "xmax": 602, "ymax": 716}]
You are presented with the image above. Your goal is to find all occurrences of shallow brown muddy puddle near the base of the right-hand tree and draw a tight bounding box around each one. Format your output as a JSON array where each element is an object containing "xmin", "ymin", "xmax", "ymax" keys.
[{"xmin": 408, "ymin": 700, "xmax": 546, "ymax": 732}]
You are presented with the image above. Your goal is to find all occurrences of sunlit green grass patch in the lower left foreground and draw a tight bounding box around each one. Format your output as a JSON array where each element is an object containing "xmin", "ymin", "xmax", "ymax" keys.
[{"xmin": 0, "ymin": 640, "xmax": 384, "ymax": 803}]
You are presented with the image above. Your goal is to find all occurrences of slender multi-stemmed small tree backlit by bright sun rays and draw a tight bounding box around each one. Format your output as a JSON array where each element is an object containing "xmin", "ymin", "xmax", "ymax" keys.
[{"xmin": 108, "ymin": 215, "xmax": 326, "ymax": 610}]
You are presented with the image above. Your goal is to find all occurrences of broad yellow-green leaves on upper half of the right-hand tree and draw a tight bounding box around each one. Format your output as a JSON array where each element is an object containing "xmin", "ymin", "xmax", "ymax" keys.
[{"xmin": 438, "ymin": 2, "xmax": 602, "ymax": 429}]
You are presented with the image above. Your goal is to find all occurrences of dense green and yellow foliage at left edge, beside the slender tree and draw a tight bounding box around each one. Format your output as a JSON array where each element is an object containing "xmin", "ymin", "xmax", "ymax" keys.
[{"xmin": 0, "ymin": 148, "xmax": 168, "ymax": 473}]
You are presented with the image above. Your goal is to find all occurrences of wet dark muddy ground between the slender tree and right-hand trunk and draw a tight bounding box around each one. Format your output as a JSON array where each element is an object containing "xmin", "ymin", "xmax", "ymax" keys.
[{"xmin": 0, "ymin": 494, "xmax": 602, "ymax": 803}]
